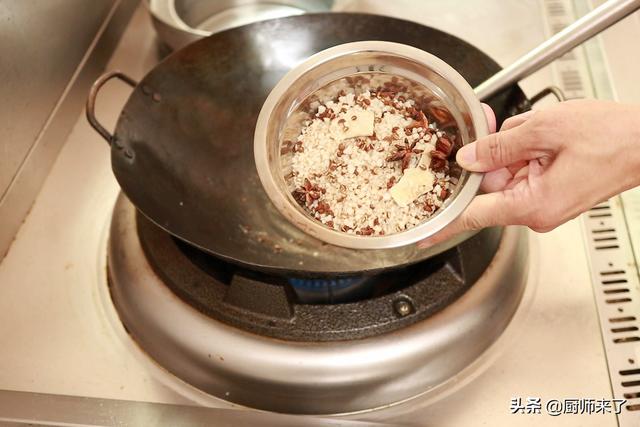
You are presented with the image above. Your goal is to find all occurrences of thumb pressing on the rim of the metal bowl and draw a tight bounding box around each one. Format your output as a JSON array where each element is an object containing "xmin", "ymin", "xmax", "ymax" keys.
[{"xmin": 456, "ymin": 125, "xmax": 533, "ymax": 172}]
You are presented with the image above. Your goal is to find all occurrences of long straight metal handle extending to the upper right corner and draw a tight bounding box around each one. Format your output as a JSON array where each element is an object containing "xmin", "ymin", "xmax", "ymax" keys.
[{"xmin": 475, "ymin": 0, "xmax": 640, "ymax": 99}]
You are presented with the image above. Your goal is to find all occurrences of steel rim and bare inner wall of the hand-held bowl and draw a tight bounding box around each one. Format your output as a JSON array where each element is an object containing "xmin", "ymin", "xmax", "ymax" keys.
[{"xmin": 254, "ymin": 41, "xmax": 489, "ymax": 249}]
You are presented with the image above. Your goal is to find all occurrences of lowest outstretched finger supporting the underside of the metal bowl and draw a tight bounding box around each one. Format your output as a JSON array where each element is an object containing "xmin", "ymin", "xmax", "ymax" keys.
[{"xmin": 418, "ymin": 192, "xmax": 517, "ymax": 248}]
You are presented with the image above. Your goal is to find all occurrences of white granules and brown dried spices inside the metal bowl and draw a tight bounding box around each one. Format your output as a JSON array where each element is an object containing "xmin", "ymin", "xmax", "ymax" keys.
[{"xmin": 282, "ymin": 76, "xmax": 454, "ymax": 236}]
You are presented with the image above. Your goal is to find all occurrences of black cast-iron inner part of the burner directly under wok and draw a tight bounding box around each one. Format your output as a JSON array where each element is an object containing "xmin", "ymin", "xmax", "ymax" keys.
[{"xmin": 136, "ymin": 207, "xmax": 502, "ymax": 342}]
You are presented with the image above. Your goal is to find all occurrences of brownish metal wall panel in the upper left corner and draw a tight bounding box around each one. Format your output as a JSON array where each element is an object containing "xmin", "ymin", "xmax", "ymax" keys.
[{"xmin": 0, "ymin": 0, "xmax": 137, "ymax": 260}]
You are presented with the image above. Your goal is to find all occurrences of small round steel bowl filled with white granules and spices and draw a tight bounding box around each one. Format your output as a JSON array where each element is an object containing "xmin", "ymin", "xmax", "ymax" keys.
[{"xmin": 254, "ymin": 41, "xmax": 488, "ymax": 249}]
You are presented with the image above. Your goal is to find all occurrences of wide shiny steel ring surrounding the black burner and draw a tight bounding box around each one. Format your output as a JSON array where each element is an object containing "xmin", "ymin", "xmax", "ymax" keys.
[{"xmin": 109, "ymin": 197, "xmax": 528, "ymax": 414}]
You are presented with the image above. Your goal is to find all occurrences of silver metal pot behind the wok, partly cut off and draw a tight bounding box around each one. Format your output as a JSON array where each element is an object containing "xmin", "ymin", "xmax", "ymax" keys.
[{"xmin": 143, "ymin": 0, "xmax": 334, "ymax": 49}]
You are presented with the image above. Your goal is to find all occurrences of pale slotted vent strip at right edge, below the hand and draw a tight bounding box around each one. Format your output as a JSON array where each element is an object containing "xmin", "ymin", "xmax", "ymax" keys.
[{"xmin": 583, "ymin": 197, "xmax": 640, "ymax": 427}]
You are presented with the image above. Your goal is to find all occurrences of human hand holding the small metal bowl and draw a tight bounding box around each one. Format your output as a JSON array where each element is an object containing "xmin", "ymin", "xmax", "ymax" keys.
[{"xmin": 418, "ymin": 100, "xmax": 640, "ymax": 247}]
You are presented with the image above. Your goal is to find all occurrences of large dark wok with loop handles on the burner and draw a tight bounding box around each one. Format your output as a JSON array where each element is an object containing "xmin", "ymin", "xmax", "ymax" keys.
[{"xmin": 87, "ymin": 13, "xmax": 530, "ymax": 275}]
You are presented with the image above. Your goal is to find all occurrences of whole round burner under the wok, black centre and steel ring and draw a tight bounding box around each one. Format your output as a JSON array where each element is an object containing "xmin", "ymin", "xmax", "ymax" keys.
[{"xmin": 108, "ymin": 196, "xmax": 527, "ymax": 414}]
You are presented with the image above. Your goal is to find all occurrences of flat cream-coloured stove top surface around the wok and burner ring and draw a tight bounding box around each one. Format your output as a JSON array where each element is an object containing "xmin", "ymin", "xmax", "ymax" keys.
[{"xmin": 0, "ymin": 0, "xmax": 640, "ymax": 426}]
